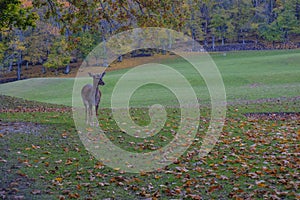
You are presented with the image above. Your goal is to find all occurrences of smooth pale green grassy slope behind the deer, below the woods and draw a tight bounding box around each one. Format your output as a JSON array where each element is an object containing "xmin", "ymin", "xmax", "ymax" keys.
[{"xmin": 0, "ymin": 50, "xmax": 300, "ymax": 107}]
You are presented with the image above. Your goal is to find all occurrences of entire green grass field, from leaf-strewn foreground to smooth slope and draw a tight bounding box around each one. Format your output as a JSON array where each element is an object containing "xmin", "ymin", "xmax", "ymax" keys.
[{"xmin": 0, "ymin": 50, "xmax": 300, "ymax": 199}]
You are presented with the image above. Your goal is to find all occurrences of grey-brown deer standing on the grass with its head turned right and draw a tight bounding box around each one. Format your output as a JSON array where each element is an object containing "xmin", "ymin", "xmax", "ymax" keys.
[{"xmin": 81, "ymin": 72, "xmax": 105, "ymax": 124}]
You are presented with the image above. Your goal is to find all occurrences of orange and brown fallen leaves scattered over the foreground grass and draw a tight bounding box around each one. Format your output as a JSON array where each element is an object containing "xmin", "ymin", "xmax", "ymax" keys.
[{"xmin": 0, "ymin": 95, "xmax": 300, "ymax": 199}]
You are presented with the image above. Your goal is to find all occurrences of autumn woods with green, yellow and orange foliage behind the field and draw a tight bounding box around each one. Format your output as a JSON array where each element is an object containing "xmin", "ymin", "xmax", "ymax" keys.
[{"xmin": 0, "ymin": 0, "xmax": 300, "ymax": 78}]
